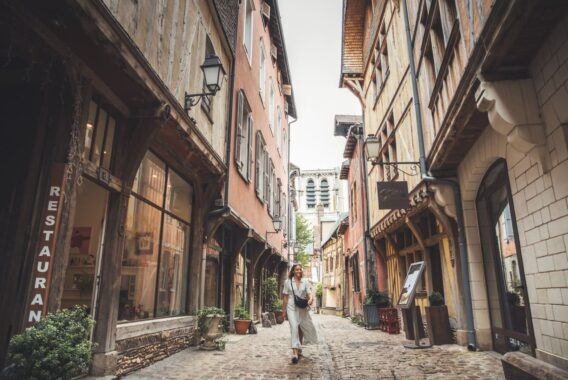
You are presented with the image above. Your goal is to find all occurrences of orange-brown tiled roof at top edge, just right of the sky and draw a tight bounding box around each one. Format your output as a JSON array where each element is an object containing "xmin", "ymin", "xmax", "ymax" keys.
[{"xmin": 341, "ymin": 0, "xmax": 367, "ymax": 78}]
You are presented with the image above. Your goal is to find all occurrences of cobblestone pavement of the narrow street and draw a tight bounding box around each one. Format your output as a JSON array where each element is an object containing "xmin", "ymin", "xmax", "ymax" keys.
[{"xmin": 126, "ymin": 315, "xmax": 504, "ymax": 380}]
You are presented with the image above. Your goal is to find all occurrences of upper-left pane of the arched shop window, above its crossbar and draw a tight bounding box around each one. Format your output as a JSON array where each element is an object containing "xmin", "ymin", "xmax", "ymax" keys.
[{"xmin": 132, "ymin": 152, "xmax": 166, "ymax": 206}]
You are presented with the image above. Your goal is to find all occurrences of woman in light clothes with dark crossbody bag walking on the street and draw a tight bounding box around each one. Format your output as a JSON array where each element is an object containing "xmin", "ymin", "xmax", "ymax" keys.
[{"xmin": 282, "ymin": 264, "xmax": 318, "ymax": 364}]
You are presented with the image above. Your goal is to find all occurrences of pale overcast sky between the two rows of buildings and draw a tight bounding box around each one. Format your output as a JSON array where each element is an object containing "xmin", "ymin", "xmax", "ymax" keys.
[{"xmin": 278, "ymin": 0, "xmax": 361, "ymax": 169}]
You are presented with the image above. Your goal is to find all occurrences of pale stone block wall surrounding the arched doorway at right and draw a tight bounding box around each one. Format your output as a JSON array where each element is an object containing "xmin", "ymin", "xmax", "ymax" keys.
[{"xmin": 459, "ymin": 13, "xmax": 568, "ymax": 368}]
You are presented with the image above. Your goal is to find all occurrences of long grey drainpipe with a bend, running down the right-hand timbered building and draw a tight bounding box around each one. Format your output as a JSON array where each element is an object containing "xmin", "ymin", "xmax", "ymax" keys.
[{"xmin": 402, "ymin": 0, "xmax": 477, "ymax": 351}]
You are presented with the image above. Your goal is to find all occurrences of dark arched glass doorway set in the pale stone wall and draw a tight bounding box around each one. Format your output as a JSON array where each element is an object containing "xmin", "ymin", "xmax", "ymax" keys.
[{"xmin": 476, "ymin": 160, "xmax": 535, "ymax": 355}]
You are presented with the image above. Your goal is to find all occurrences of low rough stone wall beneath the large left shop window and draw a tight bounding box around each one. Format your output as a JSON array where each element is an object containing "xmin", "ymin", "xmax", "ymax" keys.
[{"xmin": 116, "ymin": 326, "xmax": 196, "ymax": 376}]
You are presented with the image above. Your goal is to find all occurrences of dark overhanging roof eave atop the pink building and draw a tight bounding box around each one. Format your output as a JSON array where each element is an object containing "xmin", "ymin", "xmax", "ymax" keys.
[{"xmin": 266, "ymin": 0, "xmax": 297, "ymax": 118}]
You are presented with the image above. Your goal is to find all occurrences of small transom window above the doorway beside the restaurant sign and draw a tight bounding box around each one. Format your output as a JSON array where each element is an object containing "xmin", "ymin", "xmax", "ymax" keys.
[{"xmin": 83, "ymin": 100, "xmax": 116, "ymax": 169}]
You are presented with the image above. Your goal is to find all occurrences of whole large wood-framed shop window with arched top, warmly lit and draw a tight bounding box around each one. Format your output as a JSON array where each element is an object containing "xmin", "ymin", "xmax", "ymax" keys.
[{"xmin": 119, "ymin": 152, "xmax": 193, "ymax": 321}]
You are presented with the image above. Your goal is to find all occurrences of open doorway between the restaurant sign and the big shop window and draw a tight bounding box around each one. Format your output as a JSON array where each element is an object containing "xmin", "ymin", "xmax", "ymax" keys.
[{"xmin": 61, "ymin": 179, "xmax": 108, "ymax": 316}]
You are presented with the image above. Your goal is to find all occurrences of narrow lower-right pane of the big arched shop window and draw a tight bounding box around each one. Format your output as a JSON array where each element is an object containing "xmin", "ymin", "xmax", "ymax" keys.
[{"xmin": 157, "ymin": 215, "xmax": 189, "ymax": 317}]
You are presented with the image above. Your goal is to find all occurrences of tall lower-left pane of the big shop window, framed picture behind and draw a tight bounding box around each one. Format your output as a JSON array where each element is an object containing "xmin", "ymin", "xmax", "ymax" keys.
[{"xmin": 118, "ymin": 197, "xmax": 160, "ymax": 320}]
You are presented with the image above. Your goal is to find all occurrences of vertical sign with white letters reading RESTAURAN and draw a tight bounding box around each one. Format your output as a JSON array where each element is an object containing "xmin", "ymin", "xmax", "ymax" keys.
[{"xmin": 25, "ymin": 163, "xmax": 67, "ymax": 326}]
